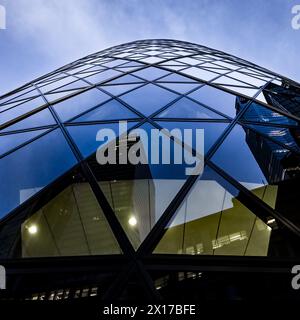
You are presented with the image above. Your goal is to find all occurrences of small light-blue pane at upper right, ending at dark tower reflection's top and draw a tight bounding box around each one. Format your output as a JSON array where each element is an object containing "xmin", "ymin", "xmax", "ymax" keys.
[{"xmin": 189, "ymin": 85, "xmax": 236, "ymax": 117}]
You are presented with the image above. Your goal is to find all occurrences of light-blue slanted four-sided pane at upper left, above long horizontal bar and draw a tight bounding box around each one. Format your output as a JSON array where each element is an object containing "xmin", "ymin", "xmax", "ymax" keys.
[{"xmin": 53, "ymin": 89, "xmax": 110, "ymax": 121}]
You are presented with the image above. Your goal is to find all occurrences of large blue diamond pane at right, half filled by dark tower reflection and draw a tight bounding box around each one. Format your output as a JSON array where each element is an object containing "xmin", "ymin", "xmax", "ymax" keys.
[{"xmin": 212, "ymin": 125, "xmax": 300, "ymax": 208}]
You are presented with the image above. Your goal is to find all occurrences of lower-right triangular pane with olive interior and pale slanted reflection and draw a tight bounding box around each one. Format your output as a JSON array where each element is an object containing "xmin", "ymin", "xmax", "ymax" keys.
[{"xmin": 154, "ymin": 167, "xmax": 272, "ymax": 256}]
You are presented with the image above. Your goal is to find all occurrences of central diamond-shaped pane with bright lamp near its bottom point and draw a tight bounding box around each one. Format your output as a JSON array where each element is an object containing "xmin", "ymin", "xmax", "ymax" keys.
[{"xmin": 89, "ymin": 124, "xmax": 196, "ymax": 249}]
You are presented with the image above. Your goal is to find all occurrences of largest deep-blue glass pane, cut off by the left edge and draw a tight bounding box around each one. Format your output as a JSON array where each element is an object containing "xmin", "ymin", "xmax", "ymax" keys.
[{"xmin": 0, "ymin": 130, "xmax": 76, "ymax": 218}]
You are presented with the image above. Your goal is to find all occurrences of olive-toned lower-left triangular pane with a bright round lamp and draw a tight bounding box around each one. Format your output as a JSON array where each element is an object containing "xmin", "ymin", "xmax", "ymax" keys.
[{"xmin": 20, "ymin": 172, "xmax": 122, "ymax": 258}]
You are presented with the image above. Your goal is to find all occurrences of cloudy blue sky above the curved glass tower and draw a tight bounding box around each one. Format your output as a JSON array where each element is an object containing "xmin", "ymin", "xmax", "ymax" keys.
[{"xmin": 0, "ymin": 0, "xmax": 300, "ymax": 95}]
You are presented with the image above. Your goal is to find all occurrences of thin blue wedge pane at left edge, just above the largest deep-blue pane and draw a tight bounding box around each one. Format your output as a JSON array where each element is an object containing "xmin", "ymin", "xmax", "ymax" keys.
[{"xmin": 0, "ymin": 130, "xmax": 46, "ymax": 155}]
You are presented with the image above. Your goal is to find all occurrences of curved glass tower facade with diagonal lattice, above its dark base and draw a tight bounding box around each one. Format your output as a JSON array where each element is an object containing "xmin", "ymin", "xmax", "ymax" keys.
[{"xmin": 0, "ymin": 40, "xmax": 300, "ymax": 258}]
